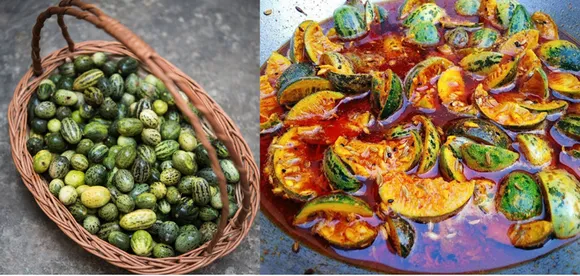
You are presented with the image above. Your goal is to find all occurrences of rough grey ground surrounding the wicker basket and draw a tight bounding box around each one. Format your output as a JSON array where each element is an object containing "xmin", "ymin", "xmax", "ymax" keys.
[{"xmin": 0, "ymin": 0, "xmax": 259, "ymax": 274}]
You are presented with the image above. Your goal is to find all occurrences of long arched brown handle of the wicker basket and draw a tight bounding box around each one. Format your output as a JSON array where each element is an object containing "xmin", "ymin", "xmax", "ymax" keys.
[{"xmin": 31, "ymin": 0, "xmax": 251, "ymax": 253}]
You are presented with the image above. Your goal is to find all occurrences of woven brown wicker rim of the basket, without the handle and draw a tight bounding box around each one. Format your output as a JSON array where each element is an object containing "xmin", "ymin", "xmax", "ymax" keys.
[{"xmin": 8, "ymin": 40, "xmax": 259, "ymax": 274}]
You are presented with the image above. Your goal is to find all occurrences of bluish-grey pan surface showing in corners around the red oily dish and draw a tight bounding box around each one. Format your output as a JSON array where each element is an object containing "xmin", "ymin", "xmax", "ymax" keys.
[{"xmin": 259, "ymin": 0, "xmax": 580, "ymax": 274}]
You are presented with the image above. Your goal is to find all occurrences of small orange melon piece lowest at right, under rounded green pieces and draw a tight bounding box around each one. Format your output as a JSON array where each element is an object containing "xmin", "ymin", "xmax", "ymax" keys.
[{"xmin": 508, "ymin": 220, "xmax": 554, "ymax": 249}]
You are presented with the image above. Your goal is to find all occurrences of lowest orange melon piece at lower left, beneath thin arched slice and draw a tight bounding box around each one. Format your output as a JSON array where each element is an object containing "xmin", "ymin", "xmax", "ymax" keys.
[{"xmin": 313, "ymin": 220, "xmax": 379, "ymax": 249}]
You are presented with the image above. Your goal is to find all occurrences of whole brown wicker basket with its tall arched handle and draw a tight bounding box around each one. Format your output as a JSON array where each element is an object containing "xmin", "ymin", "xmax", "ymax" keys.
[{"xmin": 8, "ymin": 0, "xmax": 259, "ymax": 274}]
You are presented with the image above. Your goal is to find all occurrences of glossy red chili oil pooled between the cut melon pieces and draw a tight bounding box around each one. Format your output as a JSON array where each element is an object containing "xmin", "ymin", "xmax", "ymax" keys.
[{"xmin": 260, "ymin": 0, "xmax": 580, "ymax": 273}]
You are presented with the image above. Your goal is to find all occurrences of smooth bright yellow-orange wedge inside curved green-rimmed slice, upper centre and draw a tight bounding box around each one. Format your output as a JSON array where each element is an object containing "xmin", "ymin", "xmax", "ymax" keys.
[{"xmin": 437, "ymin": 67, "xmax": 478, "ymax": 115}]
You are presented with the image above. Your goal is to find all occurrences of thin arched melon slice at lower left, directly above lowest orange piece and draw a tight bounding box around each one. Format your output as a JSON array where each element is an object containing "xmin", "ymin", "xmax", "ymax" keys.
[{"xmin": 294, "ymin": 193, "xmax": 373, "ymax": 225}]
